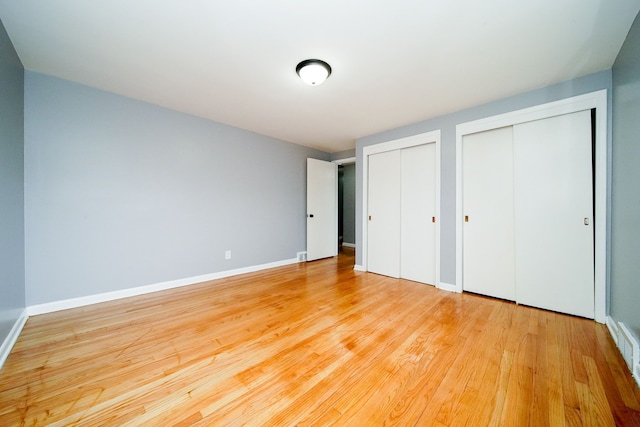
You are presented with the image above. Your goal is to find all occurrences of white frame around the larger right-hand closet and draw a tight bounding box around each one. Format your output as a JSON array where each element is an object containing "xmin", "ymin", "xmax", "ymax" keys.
[{"xmin": 452, "ymin": 89, "xmax": 609, "ymax": 323}]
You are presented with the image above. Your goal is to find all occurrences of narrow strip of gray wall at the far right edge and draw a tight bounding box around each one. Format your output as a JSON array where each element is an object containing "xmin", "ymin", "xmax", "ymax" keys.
[{"xmin": 610, "ymin": 15, "xmax": 640, "ymax": 337}]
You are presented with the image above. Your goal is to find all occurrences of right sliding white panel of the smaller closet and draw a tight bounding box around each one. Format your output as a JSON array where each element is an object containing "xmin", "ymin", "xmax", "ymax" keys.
[{"xmin": 400, "ymin": 143, "xmax": 436, "ymax": 285}]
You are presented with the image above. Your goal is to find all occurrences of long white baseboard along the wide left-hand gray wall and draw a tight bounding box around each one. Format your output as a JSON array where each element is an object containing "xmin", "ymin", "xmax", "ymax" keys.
[{"xmin": 27, "ymin": 258, "xmax": 298, "ymax": 316}]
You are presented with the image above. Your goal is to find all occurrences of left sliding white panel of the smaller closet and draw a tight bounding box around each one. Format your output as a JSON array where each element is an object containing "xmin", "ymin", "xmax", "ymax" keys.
[{"xmin": 367, "ymin": 150, "xmax": 400, "ymax": 277}]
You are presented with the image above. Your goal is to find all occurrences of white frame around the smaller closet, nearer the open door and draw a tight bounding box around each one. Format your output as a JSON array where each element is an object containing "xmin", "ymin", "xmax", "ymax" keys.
[{"xmin": 358, "ymin": 130, "xmax": 441, "ymax": 288}]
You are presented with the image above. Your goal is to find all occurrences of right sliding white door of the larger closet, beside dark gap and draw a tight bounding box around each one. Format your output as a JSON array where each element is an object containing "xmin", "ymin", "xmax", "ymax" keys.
[{"xmin": 514, "ymin": 111, "xmax": 594, "ymax": 318}]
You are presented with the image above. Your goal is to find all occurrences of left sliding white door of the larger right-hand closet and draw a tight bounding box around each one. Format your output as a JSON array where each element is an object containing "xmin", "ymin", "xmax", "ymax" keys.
[{"xmin": 462, "ymin": 127, "xmax": 515, "ymax": 300}]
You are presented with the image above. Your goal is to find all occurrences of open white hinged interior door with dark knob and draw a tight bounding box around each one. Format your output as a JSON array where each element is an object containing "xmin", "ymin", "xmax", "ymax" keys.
[{"xmin": 307, "ymin": 159, "xmax": 338, "ymax": 261}]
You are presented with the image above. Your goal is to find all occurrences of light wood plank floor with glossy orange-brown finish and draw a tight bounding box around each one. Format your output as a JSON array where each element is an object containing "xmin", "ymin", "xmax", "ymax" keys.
[{"xmin": 0, "ymin": 249, "xmax": 640, "ymax": 426}]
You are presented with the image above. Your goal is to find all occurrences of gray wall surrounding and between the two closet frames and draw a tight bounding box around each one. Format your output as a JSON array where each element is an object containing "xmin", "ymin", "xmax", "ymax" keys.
[{"xmin": 356, "ymin": 70, "xmax": 611, "ymax": 285}]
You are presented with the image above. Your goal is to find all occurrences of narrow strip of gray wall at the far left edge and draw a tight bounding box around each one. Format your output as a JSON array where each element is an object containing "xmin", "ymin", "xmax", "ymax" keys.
[{"xmin": 0, "ymin": 22, "xmax": 25, "ymax": 342}]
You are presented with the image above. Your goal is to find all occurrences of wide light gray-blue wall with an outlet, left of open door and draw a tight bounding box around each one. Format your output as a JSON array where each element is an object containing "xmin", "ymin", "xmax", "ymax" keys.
[{"xmin": 25, "ymin": 71, "xmax": 330, "ymax": 306}]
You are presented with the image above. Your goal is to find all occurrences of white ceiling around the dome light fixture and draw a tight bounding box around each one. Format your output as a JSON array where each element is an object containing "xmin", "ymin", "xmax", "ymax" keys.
[{"xmin": 0, "ymin": 0, "xmax": 640, "ymax": 152}]
